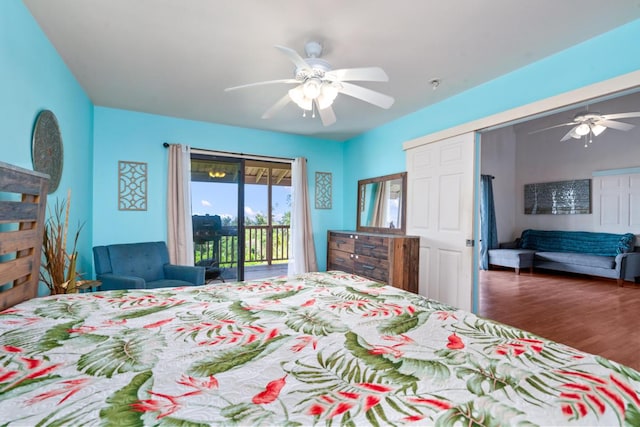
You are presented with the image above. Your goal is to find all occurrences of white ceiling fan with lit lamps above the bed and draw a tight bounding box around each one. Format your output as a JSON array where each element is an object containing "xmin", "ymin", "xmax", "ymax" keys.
[{"xmin": 225, "ymin": 41, "xmax": 394, "ymax": 126}]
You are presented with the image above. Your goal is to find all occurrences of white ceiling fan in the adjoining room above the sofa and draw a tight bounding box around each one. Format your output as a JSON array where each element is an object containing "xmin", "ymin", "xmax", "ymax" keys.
[{"xmin": 530, "ymin": 111, "xmax": 640, "ymax": 147}]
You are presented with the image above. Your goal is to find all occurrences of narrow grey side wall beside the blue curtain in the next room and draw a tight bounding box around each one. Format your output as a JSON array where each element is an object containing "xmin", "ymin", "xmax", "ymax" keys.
[{"xmin": 480, "ymin": 126, "xmax": 518, "ymax": 242}]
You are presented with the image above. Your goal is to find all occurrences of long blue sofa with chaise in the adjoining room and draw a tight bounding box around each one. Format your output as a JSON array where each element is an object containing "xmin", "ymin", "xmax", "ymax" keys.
[{"xmin": 489, "ymin": 230, "xmax": 640, "ymax": 286}]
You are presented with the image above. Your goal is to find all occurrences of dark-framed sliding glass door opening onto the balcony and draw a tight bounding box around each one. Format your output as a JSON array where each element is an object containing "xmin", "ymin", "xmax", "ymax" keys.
[{"xmin": 191, "ymin": 154, "xmax": 292, "ymax": 282}]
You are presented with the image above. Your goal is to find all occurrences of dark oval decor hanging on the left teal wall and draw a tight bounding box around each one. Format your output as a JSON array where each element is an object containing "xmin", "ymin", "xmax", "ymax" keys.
[{"xmin": 31, "ymin": 110, "xmax": 64, "ymax": 194}]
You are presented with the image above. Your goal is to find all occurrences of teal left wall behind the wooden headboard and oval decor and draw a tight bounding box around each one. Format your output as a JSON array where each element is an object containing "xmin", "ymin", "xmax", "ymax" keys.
[{"xmin": 0, "ymin": 0, "xmax": 93, "ymax": 293}]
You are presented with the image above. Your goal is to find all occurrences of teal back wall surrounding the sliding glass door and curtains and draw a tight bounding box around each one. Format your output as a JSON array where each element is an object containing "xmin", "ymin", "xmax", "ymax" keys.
[{"xmin": 93, "ymin": 107, "xmax": 342, "ymax": 269}]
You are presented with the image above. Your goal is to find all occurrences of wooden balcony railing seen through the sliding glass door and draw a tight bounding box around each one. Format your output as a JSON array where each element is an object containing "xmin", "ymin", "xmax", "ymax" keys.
[{"xmin": 194, "ymin": 225, "xmax": 289, "ymax": 267}]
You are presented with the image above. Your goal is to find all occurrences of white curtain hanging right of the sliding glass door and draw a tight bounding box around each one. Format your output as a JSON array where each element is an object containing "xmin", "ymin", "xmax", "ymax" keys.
[{"xmin": 288, "ymin": 157, "xmax": 318, "ymax": 276}]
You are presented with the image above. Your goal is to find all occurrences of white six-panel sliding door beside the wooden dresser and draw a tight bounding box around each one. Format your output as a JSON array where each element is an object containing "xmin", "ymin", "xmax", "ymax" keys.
[{"xmin": 407, "ymin": 132, "xmax": 475, "ymax": 311}]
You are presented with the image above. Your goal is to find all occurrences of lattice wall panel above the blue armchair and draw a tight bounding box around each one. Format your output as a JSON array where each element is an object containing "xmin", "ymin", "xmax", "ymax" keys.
[{"xmin": 118, "ymin": 161, "xmax": 147, "ymax": 211}]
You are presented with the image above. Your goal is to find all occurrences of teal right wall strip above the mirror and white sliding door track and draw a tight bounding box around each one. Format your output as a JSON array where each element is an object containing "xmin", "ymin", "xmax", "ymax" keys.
[{"xmin": 344, "ymin": 20, "xmax": 640, "ymax": 228}]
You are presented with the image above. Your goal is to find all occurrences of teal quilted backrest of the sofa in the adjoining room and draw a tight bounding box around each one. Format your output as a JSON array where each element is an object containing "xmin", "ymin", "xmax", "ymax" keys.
[{"xmin": 520, "ymin": 230, "xmax": 635, "ymax": 256}]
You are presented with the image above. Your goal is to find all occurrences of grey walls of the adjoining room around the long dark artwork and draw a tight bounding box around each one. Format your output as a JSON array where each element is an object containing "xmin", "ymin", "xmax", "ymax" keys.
[{"xmin": 481, "ymin": 93, "xmax": 640, "ymax": 237}]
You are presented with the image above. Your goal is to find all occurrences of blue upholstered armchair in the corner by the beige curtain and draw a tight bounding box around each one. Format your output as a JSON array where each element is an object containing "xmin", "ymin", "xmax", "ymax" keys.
[{"xmin": 93, "ymin": 242, "xmax": 205, "ymax": 290}]
